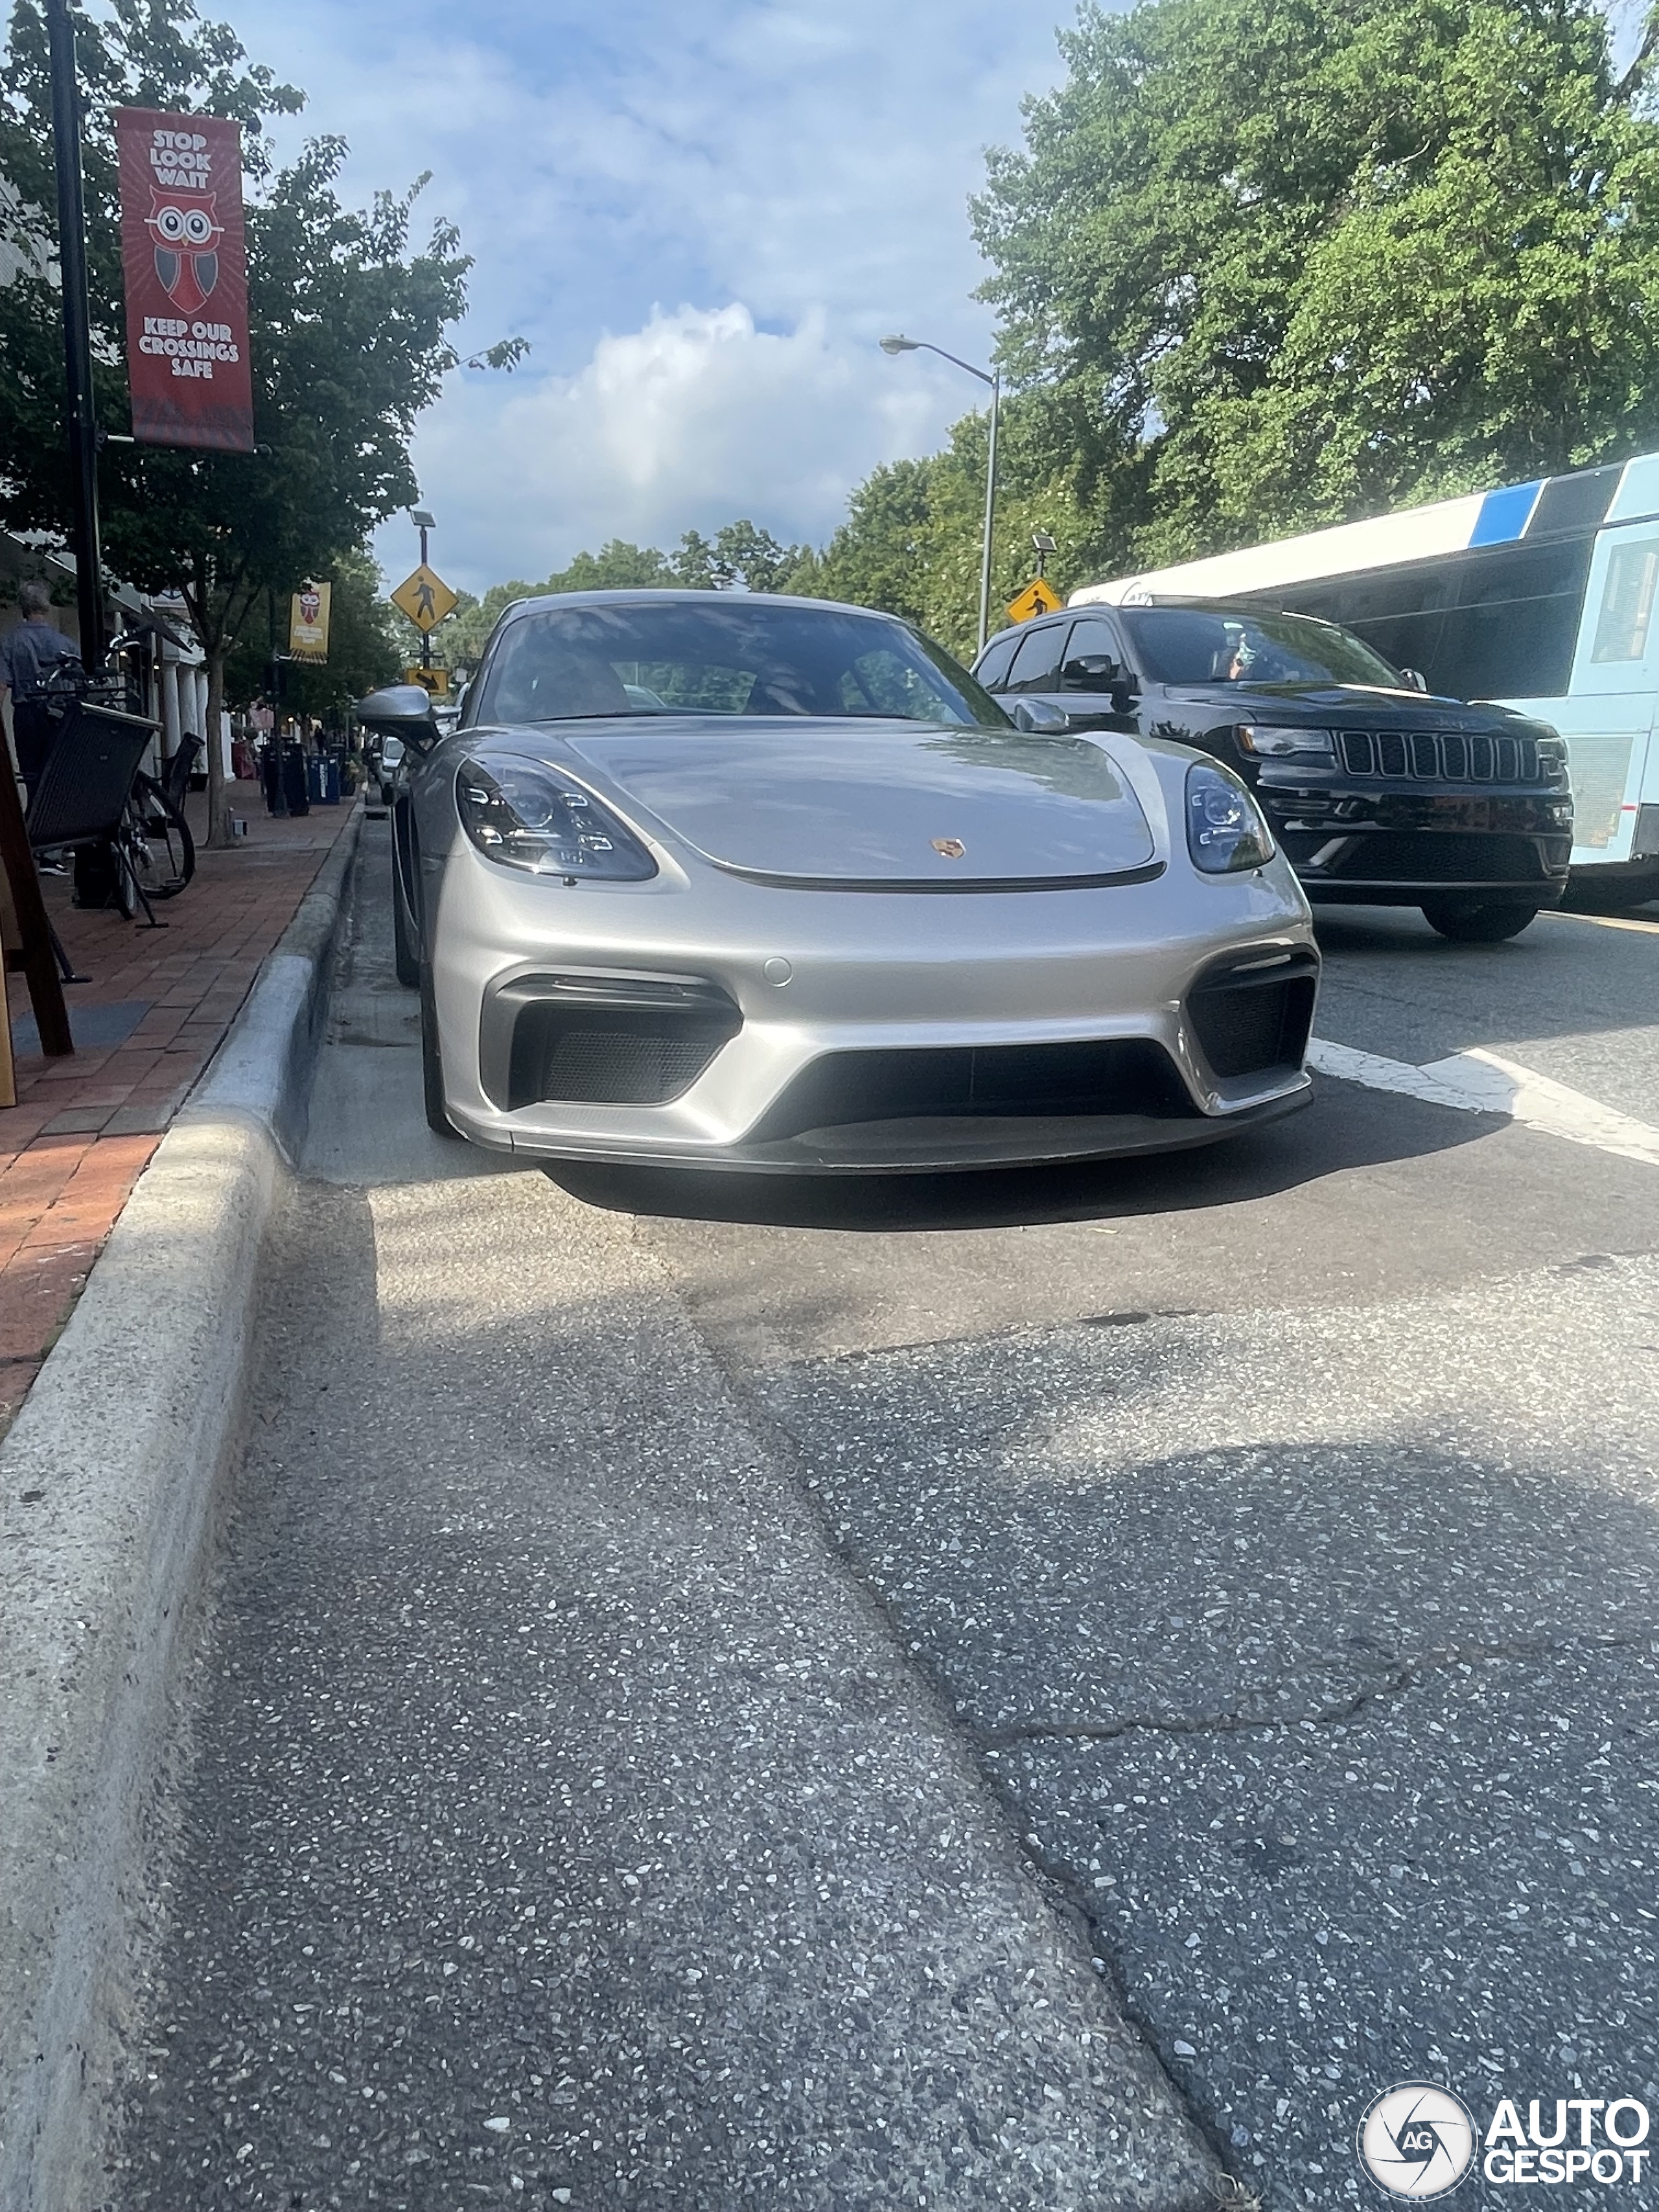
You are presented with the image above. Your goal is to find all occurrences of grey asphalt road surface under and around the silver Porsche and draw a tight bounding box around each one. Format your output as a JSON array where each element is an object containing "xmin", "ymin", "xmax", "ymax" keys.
[{"xmin": 119, "ymin": 825, "xmax": 1659, "ymax": 2212}]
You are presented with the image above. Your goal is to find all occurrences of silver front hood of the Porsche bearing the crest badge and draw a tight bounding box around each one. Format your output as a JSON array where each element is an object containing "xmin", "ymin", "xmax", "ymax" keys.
[{"xmin": 480, "ymin": 714, "xmax": 1161, "ymax": 891}]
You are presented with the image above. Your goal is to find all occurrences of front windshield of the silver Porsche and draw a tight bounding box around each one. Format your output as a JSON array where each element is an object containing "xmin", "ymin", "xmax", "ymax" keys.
[{"xmin": 467, "ymin": 593, "xmax": 1008, "ymax": 730}]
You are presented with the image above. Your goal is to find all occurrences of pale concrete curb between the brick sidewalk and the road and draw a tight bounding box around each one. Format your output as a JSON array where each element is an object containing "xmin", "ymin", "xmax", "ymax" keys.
[{"xmin": 0, "ymin": 808, "xmax": 363, "ymax": 2212}]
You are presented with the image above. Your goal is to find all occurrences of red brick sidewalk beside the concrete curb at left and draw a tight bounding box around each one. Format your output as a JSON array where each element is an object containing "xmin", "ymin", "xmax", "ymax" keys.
[{"xmin": 0, "ymin": 783, "xmax": 352, "ymax": 1434}]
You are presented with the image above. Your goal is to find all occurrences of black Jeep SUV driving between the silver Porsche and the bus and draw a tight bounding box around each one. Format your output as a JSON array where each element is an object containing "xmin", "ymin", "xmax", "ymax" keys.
[{"xmin": 973, "ymin": 600, "xmax": 1573, "ymax": 944}]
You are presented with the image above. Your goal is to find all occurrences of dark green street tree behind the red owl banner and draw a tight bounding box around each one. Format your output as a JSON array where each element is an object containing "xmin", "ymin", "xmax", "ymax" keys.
[{"xmin": 0, "ymin": 0, "xmax": 520, "ymax": 841}]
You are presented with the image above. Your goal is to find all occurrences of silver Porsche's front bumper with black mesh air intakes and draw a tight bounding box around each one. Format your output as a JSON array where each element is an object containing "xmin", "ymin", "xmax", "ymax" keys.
[{"xmin": 427, "ymin": 847, "xmax": 1318, "ymax": 1172}]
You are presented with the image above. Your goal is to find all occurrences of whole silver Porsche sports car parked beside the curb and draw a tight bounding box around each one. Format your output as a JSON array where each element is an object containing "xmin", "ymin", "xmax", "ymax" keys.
[{"xmin": 360, "ymin": 590, "xmax": 1318, "ymax": 1172}]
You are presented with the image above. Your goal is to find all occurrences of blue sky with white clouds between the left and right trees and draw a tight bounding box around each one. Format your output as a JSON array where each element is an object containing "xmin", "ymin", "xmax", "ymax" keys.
[{"xmin": 203, "ymin": 0, "xmax": 1073, "ymax": 590}]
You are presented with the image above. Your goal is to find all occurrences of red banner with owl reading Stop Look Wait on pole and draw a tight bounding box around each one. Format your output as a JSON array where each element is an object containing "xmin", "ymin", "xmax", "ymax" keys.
[{"xmin": 115, "ymin": 108, "xmax": 255, "ymax": 454}]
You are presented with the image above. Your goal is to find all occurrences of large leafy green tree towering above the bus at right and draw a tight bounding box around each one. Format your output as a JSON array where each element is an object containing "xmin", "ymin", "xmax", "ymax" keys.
[{"xmin": 975, "ymin": 0, "xmax": 1659, "ymax": 564}]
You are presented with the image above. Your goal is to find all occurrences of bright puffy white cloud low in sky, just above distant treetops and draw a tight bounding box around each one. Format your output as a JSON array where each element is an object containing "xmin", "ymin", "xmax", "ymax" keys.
[{"xmin": 391, "ymin": 305, "xmax": 960, "ymax": 590}]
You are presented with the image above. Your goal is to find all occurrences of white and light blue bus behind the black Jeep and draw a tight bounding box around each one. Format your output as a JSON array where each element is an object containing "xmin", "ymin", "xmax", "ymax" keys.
[{"xmin": 1071, "ymin": 454, "xmax": 1659, "ymax": 900}]
